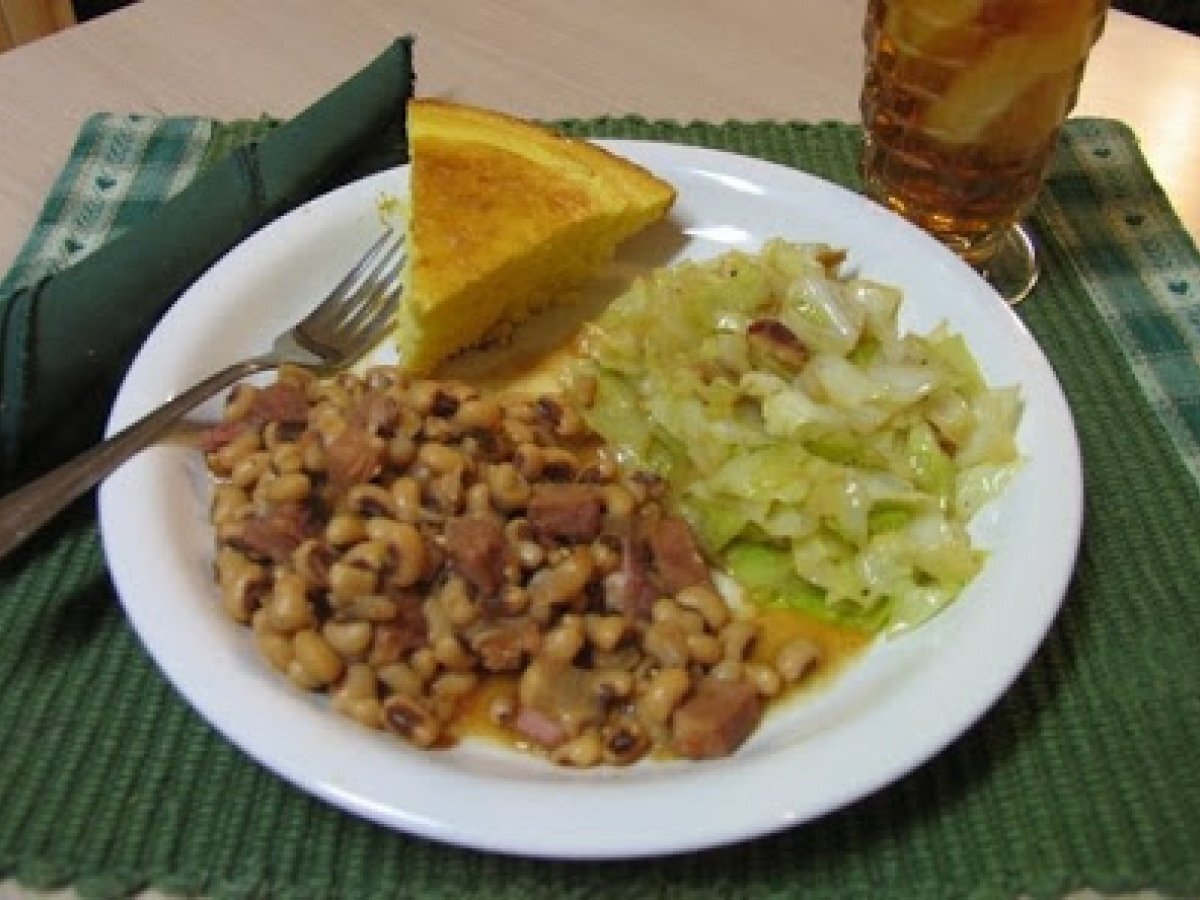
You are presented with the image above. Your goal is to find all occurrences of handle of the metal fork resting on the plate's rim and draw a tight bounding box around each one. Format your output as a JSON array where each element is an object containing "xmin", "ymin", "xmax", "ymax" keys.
[{"xmin": 0, "ymin": 354, "xmax": 280, "ymax": 559}]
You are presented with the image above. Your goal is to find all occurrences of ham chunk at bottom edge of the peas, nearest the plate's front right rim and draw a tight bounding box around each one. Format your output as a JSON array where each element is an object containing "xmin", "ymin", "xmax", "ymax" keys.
[{"xmin": 671, "ymin": 678, "xmax": 762, "ymax": 760}]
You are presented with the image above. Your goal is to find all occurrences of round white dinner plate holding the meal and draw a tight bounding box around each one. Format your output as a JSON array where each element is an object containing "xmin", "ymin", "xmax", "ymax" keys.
[{"xmin": 100, "ymin": 142, "xmax": 1082, "ymax": 858}]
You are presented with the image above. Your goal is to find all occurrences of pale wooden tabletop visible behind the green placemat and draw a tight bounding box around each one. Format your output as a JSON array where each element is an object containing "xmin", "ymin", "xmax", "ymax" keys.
[{"xmin": 0, "ymin": 0, "xmax": 1200, "ymax": 274}]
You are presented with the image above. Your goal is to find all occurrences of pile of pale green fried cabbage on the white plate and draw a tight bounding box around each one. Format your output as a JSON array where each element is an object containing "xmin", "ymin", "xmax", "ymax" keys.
[{"xmin": 568, "ymin": 240, "xmax": 1021, "ymax": 631}]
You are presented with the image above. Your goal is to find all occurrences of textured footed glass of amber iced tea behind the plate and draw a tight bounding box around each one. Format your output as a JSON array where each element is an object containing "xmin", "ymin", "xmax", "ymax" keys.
[{"xmin": 862, "ymin": 0, "xmax": 1109, "ymax": 302}]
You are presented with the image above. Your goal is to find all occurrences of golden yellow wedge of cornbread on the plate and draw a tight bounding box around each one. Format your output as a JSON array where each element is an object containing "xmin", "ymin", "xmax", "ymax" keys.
[{"xmin": 396, "ymin": 100, "xmax": 674, "ymax": 373}]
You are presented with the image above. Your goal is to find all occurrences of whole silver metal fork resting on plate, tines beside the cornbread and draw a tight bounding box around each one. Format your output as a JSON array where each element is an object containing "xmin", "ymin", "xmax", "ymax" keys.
[{"xmin": 0, "ymin": 229, "xmax": 404, "ymax": 558}]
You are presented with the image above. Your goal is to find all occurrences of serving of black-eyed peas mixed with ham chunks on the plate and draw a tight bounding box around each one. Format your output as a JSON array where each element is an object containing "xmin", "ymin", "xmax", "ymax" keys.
[{"xmin": 205, "ymin": 367, "xmax": 818, "ymax": 767}]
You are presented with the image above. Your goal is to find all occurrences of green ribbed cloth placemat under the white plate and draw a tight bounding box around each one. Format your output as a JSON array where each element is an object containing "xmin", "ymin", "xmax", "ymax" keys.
[{"xmin": 0, "ymin": 118, "xmax": 1200, "ymax": 900}]
